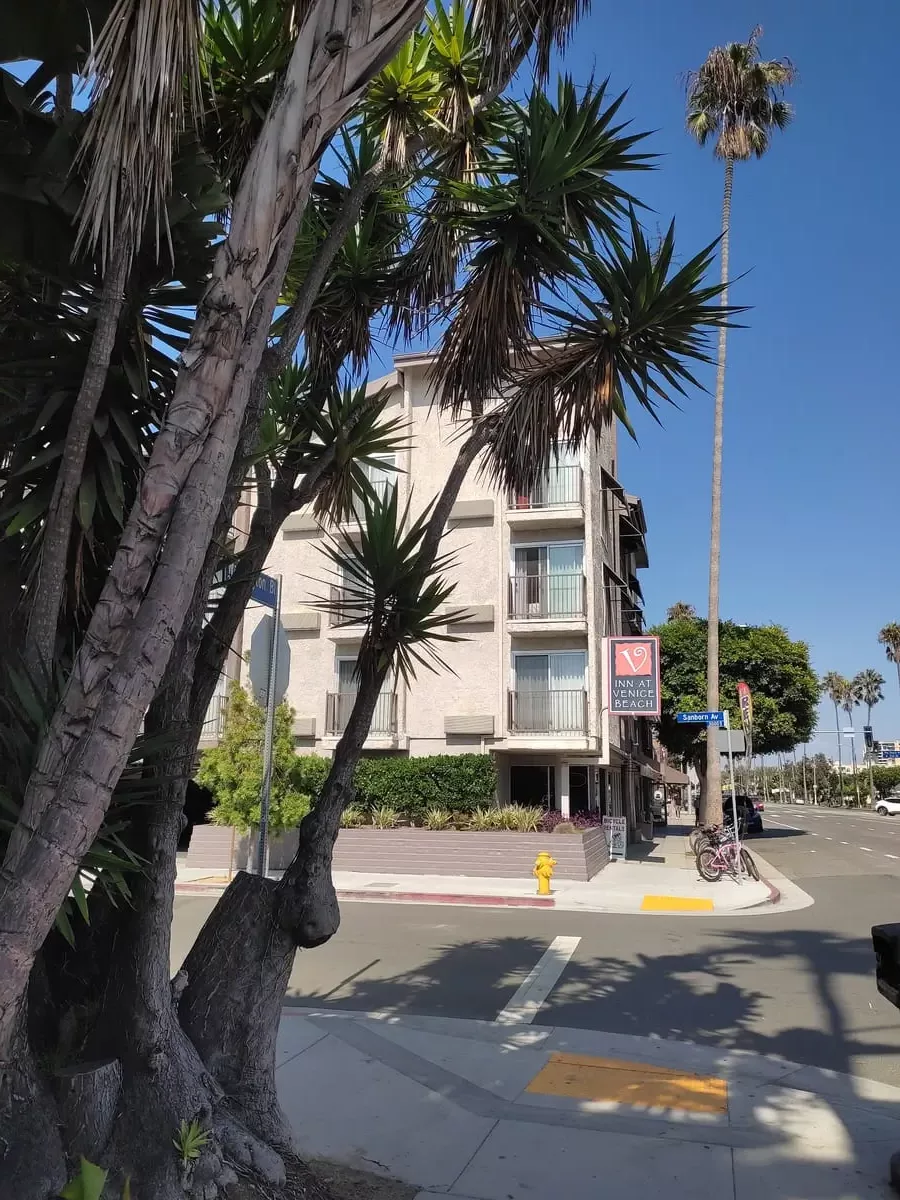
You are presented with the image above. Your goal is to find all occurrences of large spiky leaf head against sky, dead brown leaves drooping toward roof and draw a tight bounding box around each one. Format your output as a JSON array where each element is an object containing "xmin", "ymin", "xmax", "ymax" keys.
[{"xmin": 434, "ymin": 78, "xmax": 650, "ymax": 415}]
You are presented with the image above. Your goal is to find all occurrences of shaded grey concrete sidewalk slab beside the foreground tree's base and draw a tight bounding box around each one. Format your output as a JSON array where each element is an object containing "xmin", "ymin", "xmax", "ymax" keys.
[{"xmin": 276, "ymin": 1036, "xmax": 494, "ymax": 1189}]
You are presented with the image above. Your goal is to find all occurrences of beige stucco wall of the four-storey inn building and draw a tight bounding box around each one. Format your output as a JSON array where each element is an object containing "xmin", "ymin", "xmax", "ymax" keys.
[{"xmin": 244, "ymin": 362, "xmax": 643, "ymax": 762}]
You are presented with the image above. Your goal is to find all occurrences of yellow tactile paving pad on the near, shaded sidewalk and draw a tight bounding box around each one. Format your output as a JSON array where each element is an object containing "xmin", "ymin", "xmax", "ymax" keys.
[{"xmin": 526, "ymin": 1054, "xmax": 728, "ymax": 1114}]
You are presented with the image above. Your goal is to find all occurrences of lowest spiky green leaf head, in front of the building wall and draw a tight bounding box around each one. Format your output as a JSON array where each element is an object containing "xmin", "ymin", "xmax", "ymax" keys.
[{"xmin": 318, "ymin": 487, "xmax": 462, "ymax": 685}]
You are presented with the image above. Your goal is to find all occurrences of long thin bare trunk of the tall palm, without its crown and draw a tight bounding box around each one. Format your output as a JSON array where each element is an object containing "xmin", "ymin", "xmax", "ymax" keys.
[{"xmin": 702, "ymin": 156, "xmax": 734, "ymax": 824}]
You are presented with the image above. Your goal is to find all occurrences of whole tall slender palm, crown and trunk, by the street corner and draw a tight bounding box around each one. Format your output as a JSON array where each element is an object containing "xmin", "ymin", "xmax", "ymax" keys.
[{"xmin": 688, "ymin": 32, "xmax": 794, "ymax": 823}]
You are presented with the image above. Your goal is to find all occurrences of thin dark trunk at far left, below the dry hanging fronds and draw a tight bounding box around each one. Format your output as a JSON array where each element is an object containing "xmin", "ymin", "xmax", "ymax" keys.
[{"xmin": 24, "ymin": 243, "xmax": 131, "ymax": 680}]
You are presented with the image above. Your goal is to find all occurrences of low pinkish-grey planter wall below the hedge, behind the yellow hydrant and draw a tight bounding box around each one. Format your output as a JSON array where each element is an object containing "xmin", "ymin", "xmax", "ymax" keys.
[{"xmin": 186, "ymin": 826, "xmax": 610, "ymax": 882}]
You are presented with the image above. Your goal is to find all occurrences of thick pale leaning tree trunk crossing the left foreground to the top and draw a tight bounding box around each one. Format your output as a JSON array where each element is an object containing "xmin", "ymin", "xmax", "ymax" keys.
[{"xmin": 0, "ymin": 0, "xmax": 422, "ymax": 1058}]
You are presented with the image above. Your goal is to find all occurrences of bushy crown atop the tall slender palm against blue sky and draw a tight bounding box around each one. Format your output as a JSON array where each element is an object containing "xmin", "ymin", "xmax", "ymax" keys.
[{"xmin": 688, "ymin": 25, "xmax": 796, "ymax": 160}]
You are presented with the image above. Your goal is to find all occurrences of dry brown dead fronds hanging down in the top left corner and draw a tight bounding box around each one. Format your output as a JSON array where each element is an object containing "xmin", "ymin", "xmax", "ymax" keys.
[{"xmin": 77, "ymin": 0, "xmax": 200, "ymax": 264}]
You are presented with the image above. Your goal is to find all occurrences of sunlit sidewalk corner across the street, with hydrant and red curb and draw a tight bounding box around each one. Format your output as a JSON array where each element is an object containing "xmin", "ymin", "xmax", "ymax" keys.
[{"xmin": 176, "ymin": 826, "xmax": 812, "ymax": 917}]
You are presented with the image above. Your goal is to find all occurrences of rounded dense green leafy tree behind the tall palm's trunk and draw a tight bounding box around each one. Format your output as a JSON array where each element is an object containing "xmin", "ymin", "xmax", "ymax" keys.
[{"xmin": 650, "ymin": 619, "xmax": 817, "ymax": 794}]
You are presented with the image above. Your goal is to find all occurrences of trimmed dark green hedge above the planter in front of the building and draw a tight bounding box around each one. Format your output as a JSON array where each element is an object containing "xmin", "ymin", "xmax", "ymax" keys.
[{"xmin": 295, "ymin": 754, "xmax": 497, "ymax": 820}]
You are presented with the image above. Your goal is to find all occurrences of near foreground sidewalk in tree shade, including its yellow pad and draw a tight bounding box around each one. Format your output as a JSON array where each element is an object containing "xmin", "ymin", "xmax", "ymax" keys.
[{"xmin": 276, "ymin": 1009, "xmax": 900, "ymax": 1200}]
